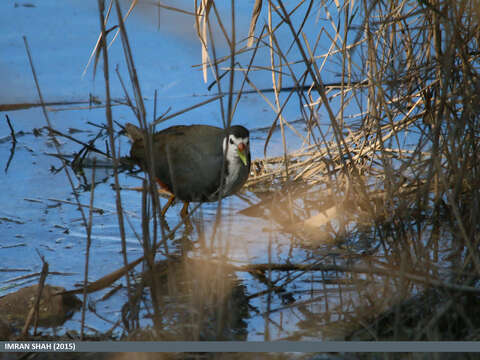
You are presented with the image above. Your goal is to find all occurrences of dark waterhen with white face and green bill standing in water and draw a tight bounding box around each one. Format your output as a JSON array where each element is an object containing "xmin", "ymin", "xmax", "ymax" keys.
[{"xmin": 125, "ymin": 124, "xmax": 250, "ymax": 216}]
